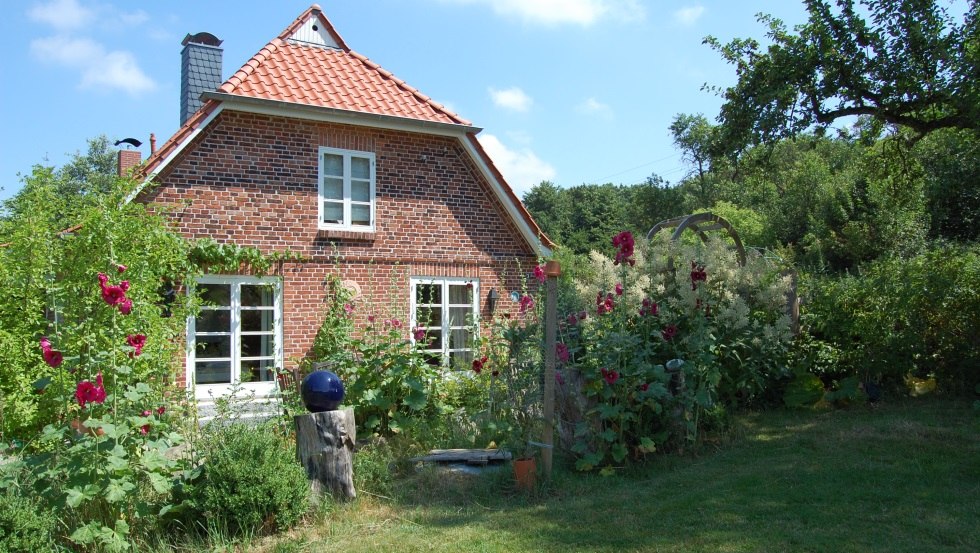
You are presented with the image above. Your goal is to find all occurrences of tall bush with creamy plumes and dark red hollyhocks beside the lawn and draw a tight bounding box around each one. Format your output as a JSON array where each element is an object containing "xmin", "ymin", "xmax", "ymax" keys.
[{"xmin": 561, "ymin": 236, "xmax": 790, "ymax": 470}]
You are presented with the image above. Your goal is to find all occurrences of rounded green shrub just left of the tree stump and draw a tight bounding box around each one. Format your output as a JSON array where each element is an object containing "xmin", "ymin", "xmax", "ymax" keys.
[{"xmin": 184, "ymin": 423, "xmax": 310, "ymax": 535}]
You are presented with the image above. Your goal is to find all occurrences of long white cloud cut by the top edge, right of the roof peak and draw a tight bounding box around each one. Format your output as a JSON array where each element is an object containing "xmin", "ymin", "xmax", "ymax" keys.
[{"xmin": 443, "ymin": 0, "xmax": 646, "ymax": 26}]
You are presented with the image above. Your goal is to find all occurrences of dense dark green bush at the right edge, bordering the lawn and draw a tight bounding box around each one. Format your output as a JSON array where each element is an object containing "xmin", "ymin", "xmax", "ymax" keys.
[{"xmin": 802, "ymin": 244, "xmax": 980, "ymax": 392}]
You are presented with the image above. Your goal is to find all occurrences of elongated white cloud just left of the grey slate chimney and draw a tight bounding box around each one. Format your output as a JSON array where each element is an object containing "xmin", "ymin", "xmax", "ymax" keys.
[{"xmin": 31, "ymin": 35, "xmax": 156, "ymax": 94}]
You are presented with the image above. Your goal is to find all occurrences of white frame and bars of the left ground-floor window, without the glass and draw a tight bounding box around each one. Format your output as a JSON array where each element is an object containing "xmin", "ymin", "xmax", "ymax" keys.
[{"xmin": 185, "ymin": 275, "xmax": 283, "ymax": 399}]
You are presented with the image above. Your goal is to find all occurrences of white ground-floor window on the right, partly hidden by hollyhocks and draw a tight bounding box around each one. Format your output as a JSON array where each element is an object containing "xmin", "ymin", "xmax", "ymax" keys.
[{"xmin": 411, "ymin": 277, "xmax": 480, "ymax": 367}]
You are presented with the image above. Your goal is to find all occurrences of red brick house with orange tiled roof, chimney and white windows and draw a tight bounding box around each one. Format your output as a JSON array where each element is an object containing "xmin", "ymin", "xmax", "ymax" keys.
[{"xmin": 136, "ymin": 4, "xmax": 553, "ymax": 408}]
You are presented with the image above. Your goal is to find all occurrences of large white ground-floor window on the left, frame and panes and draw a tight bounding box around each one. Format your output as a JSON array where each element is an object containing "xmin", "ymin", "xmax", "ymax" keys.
[{"xmin": 187, "ymin": 276, "xmax": 283, "ymax": 397}]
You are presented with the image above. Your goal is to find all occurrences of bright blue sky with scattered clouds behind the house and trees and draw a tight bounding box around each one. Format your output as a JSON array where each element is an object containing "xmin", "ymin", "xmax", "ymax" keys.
[{"xmin": 0, "ymin": 0, "xmax": 804, "ymax": 203}]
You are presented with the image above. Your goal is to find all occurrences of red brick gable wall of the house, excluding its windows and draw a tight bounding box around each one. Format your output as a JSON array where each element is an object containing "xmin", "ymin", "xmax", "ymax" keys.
[{"xmin": 141, "ymin": 111, "xmax": 535, "ymax": 366}]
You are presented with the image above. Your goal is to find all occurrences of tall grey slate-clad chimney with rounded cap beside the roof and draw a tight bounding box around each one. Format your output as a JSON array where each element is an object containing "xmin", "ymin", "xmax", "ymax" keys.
[{"xmin": 180, "ymin": 33, "xmax": 223, "ymax": 125}]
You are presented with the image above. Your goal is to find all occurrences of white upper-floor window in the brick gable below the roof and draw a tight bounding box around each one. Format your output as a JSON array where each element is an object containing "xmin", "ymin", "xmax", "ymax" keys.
[{"xmin": 319, "ymin": 147, "xmax": 375, "ymax": 231}]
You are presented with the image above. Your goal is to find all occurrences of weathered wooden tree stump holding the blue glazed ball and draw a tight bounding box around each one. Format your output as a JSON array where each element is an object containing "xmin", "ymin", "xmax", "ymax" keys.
[{"xmin": 293, "ymin": 409, "xmax": 357, "ymax": 500}]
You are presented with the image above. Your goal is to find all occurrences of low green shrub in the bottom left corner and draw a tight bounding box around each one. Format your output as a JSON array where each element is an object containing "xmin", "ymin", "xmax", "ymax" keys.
[{"xmin": 0, "ymin": 489, "xmax": 58, "ymax": 553}]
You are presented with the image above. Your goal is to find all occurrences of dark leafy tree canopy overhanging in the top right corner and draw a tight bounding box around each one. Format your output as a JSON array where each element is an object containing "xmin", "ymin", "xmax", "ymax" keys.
[{"xmin": 705, "ymin": 0, "xmax": 980, "ymax": 153}]
